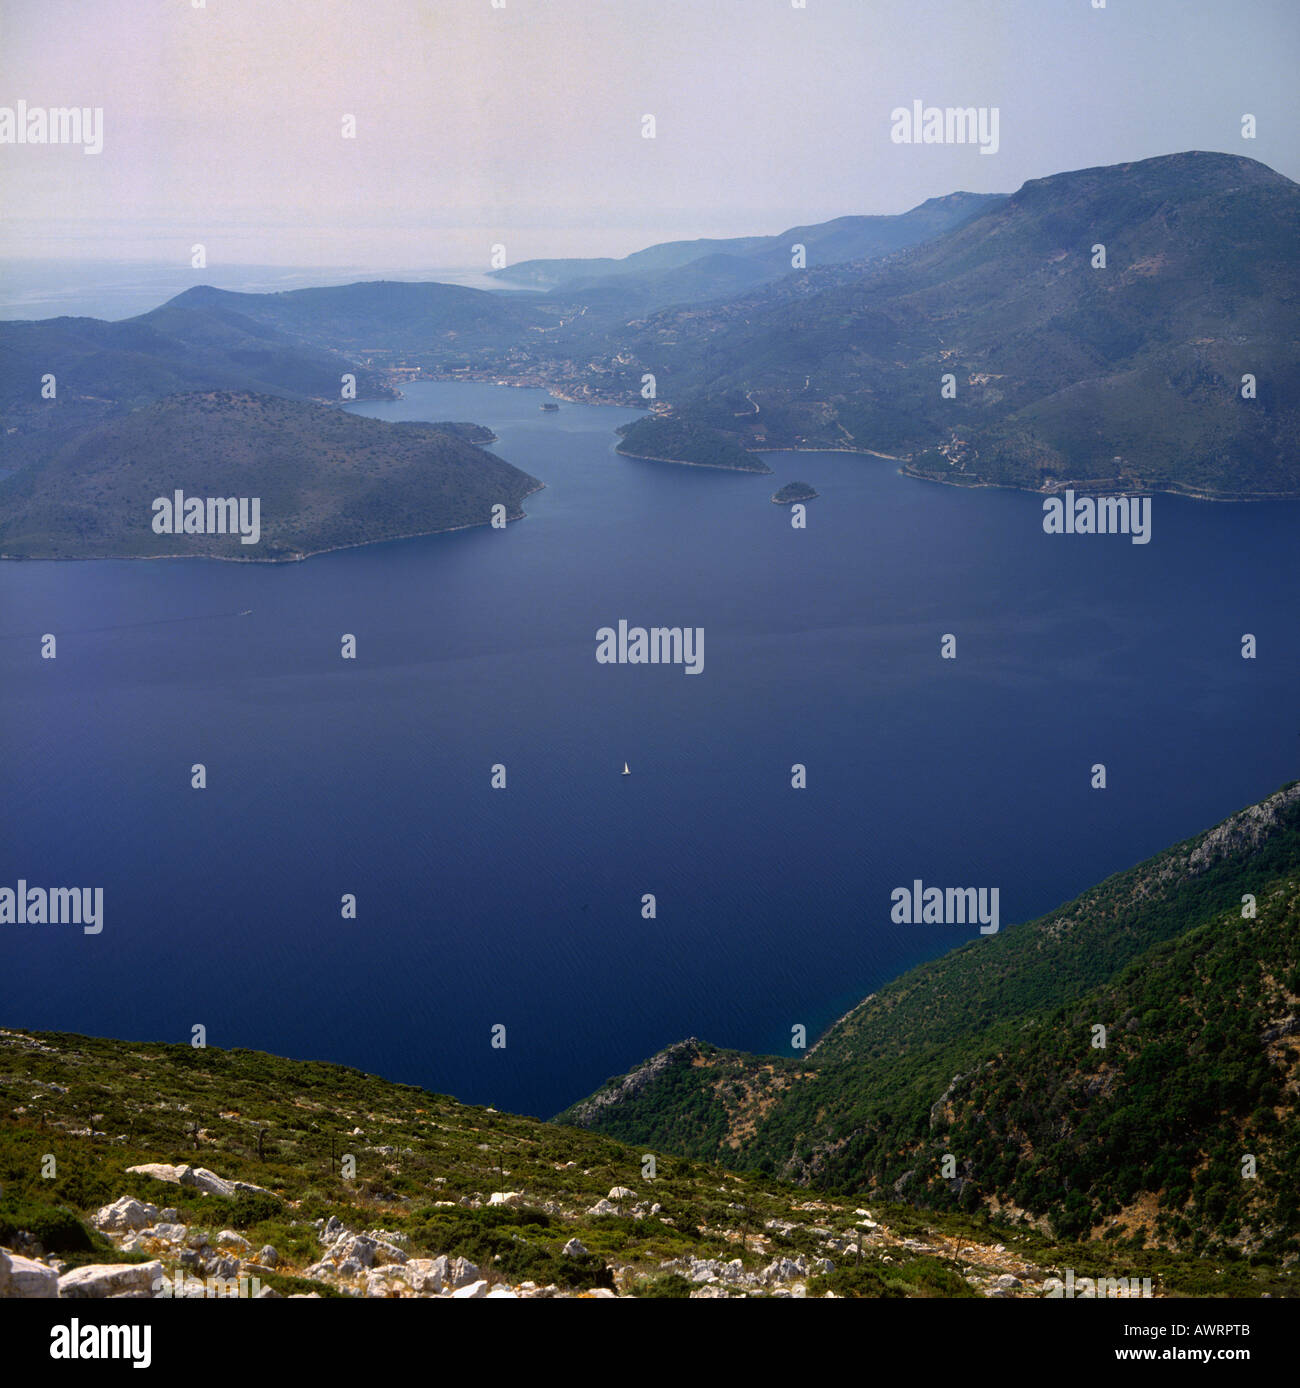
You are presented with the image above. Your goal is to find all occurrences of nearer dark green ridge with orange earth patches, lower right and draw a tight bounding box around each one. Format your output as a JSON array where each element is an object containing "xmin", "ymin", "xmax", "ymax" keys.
[{"xmin": 910, "ymin": 874, "xmax": 1300, "ymax": 1259}]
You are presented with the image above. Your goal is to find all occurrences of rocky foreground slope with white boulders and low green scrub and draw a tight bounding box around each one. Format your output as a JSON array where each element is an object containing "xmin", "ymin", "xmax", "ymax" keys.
[{"xmin": 0, "ymin": 1030, "xmax": 1248, "ymax": 1299}]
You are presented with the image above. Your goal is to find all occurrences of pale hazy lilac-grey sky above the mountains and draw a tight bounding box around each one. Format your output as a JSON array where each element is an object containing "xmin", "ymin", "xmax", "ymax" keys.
[{"xmin": 0, "ymin": 0, "xmax": 1300, "ymax": 268}]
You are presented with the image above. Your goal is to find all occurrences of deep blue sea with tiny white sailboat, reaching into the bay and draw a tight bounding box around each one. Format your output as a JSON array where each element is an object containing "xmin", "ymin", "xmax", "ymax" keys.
[{"xmin": 0, "ymin": 383, "xmax": 1300, "ymax": 1115}]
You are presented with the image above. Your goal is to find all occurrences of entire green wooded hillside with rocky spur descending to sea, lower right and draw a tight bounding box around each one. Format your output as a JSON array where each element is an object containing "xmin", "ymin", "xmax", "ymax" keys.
[{"xmin": 556, "ymin": 783, "xmax": 1300, "ymax": 1259}]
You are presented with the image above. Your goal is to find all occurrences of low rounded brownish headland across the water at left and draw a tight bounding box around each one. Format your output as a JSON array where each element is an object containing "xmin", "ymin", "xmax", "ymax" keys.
[{"xmin": 0, "ymin": 391, "xmax": 541, "ymax": 559}]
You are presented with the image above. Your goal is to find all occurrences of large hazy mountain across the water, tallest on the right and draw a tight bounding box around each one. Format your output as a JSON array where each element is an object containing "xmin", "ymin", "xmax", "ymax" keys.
[{"xmin": 610, "ymin": 153, "xmax": 1300, "ymax": 497}]
